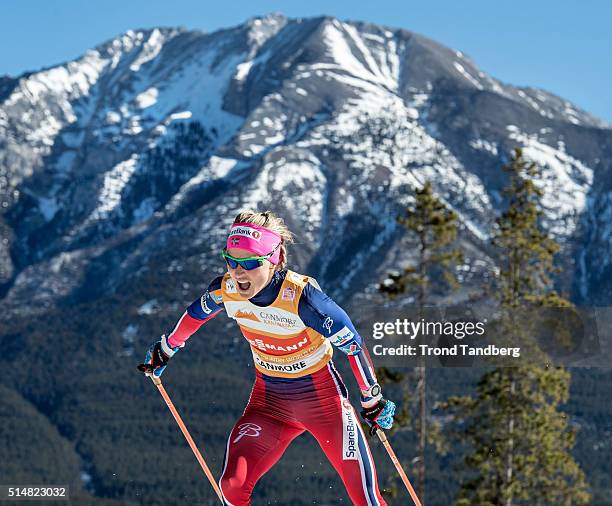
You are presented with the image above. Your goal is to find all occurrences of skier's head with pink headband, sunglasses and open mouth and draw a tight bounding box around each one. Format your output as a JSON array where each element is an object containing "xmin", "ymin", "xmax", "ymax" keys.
[{"xmin": 225, "ymin": 211, "xmax": 293, "ymax": 299}]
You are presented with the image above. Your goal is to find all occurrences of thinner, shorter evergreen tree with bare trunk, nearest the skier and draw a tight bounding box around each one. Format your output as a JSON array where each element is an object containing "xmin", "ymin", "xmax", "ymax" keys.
[{"xmin": 379, "ymin": 181, "xmax": 462, "ymax": 504}]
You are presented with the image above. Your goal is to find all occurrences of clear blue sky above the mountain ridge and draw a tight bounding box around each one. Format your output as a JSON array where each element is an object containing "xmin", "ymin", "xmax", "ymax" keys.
[{"xmin": 0, "ymin": 0, "xmax": 612, "ymax": 123}]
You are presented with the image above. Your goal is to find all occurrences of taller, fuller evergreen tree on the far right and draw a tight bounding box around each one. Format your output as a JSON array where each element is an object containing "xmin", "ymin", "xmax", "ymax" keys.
[{"xmin": 443, "ymin": 148, "xmax": 589, "ymax": 506}]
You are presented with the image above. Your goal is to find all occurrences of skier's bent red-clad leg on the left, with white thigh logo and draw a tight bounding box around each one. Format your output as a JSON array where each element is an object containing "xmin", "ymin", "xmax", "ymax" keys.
[{"xmin": 219, "ymin": 407, "xmax": 304, "ymax": 506}]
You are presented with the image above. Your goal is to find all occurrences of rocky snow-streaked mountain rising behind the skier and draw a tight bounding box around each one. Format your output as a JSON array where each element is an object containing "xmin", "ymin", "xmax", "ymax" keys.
[{"xmin": 0, "ymin": 15, "xmax": 612, "ymax": 311}]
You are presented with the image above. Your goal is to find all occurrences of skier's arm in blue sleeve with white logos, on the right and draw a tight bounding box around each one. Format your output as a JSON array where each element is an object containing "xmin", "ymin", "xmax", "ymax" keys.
[{"xmin": 299, "ymin": 283, "xmax": 381, "ymax": 404}]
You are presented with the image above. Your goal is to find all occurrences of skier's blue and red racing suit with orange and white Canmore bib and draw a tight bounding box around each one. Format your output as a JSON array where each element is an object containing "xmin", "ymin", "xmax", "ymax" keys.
[{"xmin": 168, "ymin": 270, "xmax": 386, "ymax": 506}]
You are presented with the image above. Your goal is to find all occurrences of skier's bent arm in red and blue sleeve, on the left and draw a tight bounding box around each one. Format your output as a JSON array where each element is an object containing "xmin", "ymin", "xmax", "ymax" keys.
[{"xmin": 162, "ymin": 276, "xmax": 224, "ymax": 350}]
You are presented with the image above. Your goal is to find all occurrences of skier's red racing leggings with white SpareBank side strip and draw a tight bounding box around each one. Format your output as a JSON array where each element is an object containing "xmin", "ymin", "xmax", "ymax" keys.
[{"xmin": 219, "ymin": 362, "xmax": 387, "ymax": 506}]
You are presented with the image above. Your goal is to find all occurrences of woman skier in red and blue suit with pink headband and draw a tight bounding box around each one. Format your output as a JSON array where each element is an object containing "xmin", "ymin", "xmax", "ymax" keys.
[{"xmin": 139, "ymin": 211, "xmax": 395, "ymax": 506}]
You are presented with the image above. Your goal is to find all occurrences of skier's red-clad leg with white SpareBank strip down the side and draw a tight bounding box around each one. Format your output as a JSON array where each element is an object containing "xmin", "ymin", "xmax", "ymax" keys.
[{"xmin": 300, "ymin": 364, "xmax": 387, "ymax": 506}]
